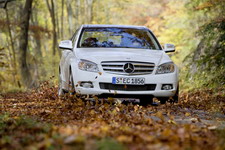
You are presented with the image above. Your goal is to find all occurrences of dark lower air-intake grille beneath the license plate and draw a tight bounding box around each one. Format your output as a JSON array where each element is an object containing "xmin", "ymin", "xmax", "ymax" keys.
[{"xmin": 99, "ymin": 83, "xmax": 156, "ymax": 91}]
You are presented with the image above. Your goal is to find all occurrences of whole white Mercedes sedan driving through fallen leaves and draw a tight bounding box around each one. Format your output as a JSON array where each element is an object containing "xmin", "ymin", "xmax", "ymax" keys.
[{"xmin": 58, "ymin": 25, "xmax": 179, "ymax": 103}]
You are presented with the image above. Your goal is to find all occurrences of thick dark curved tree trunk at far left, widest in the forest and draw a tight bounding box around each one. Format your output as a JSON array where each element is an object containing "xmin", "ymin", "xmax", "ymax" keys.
[{"xmin": 19, "ymin": 0, "xmax": 33, "ymax": 87}]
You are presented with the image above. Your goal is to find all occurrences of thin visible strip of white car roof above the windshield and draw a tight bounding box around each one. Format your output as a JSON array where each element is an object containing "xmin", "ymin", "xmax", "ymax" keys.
[{"xmin": 82, "ymin": 24, "xmax": 149, "ymax": 30}]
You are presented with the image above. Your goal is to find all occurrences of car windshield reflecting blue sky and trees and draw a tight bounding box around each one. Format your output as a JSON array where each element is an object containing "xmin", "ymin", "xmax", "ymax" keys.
[{"xmin": 78, "ymin": 28, "xmax": 160, "ymax": 50}]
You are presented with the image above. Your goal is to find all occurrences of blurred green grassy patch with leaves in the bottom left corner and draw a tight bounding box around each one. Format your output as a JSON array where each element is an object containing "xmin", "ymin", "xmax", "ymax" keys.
[{"xmin": 0, "ymin": 113, "xmax": 52, "ymax": 149}]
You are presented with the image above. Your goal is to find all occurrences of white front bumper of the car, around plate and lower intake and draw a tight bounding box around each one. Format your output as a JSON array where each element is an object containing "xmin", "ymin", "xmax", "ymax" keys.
[{"xmin": 72, "ymin": 67, "xmax": 178, "ymax": 97}]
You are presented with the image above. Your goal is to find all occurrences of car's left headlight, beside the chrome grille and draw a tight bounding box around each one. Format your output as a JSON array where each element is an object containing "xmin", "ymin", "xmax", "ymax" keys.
[{"xmin": 78, "ymin": 59, "xmax": 99, "ymax": 72}]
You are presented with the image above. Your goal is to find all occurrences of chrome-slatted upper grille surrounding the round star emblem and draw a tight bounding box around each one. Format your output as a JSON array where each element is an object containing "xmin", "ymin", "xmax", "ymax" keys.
[{"xmin": 101, "ymin": 61, "xmax": 155, "ymax": 75}]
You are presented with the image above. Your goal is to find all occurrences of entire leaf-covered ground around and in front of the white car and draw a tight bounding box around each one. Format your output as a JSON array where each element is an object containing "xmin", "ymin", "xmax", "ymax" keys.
[{"xmin": 0, "ymin": 82, "xmax": 225, "ymax": 150}]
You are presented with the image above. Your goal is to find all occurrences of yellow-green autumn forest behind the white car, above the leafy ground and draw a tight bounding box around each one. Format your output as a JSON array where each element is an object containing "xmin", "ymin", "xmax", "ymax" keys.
[{"xmin": 0, "ymin": 0, "xmax": 225, "ymax": 92}]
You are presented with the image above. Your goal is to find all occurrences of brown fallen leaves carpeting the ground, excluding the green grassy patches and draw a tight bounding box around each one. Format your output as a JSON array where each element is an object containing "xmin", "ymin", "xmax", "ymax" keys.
[{"xmin": 0, "ymin": 82, "xmax": 225, "ymax": 149}]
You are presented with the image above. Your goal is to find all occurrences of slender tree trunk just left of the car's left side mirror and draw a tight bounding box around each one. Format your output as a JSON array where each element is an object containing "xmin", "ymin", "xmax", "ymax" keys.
[{"xmin": 46, "ymin": 0, "xmax": 57, "ymax": 56}]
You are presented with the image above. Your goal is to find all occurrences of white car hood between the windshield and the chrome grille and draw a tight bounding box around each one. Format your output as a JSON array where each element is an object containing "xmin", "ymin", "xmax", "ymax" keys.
[{"xmin": 75, "ymin": 48, "xmax": 171, "ymax": 65}]
